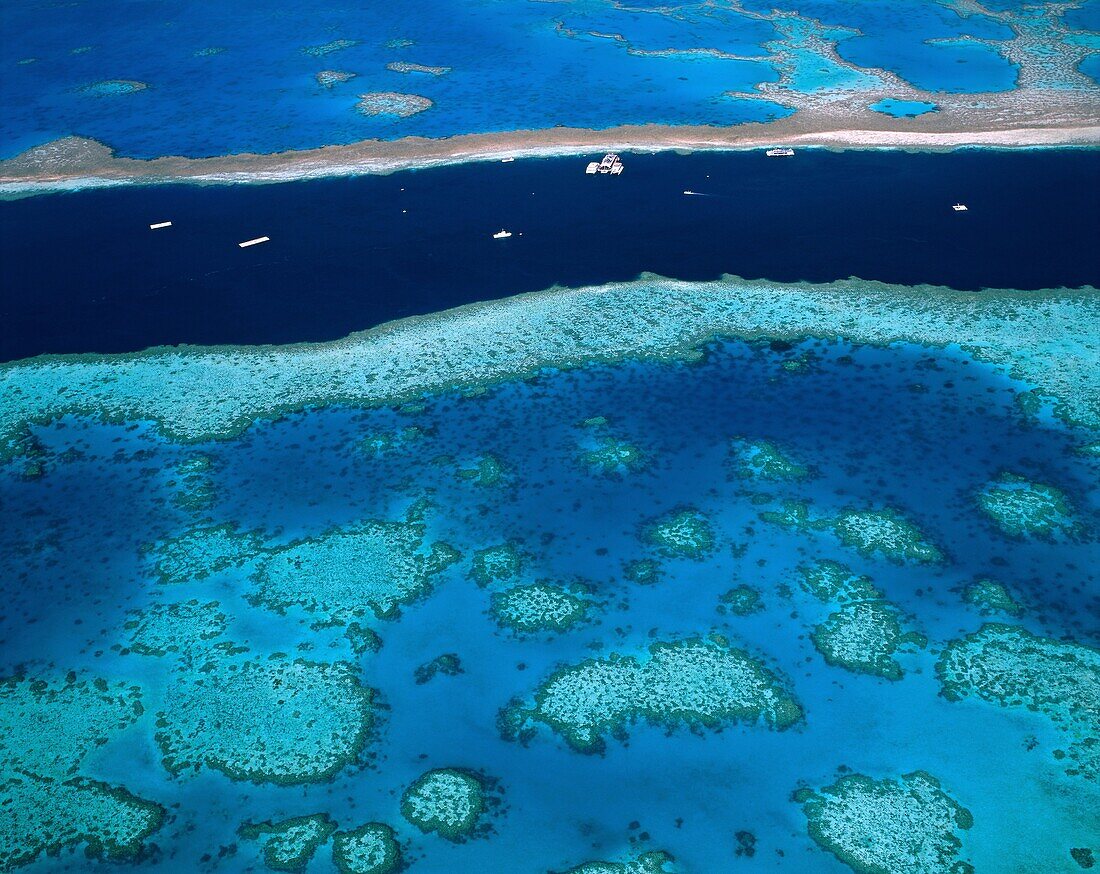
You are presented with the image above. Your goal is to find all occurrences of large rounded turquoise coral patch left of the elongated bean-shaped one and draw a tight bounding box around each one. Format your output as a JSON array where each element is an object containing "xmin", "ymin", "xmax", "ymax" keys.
[{"xmin": 156, "ymin": 654, "xmax": 374, "ymax": 785}]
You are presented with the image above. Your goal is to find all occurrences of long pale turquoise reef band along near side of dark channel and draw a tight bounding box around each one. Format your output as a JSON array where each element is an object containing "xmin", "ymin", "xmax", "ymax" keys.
[{"xmin": 0, "ymin": 276, "xmax": 1100, "ymax": 460}]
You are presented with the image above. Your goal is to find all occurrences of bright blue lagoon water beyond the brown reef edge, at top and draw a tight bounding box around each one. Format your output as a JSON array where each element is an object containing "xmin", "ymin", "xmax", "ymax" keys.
[{"xmin": 0, "ymin": 0, "xmax": 1098, "ymax": 157}]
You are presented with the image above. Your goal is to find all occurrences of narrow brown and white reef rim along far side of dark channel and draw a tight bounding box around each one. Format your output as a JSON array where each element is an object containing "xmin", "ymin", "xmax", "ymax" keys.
[{"xmin": 0, "ymin": 113, "xmax": 1100, "ymax": 200}]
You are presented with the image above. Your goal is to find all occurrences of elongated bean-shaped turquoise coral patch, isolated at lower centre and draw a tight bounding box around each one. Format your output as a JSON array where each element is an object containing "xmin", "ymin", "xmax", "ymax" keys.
[{"xmin": 499, "ymin": 635, "xmax": 802, "ymax": 753}]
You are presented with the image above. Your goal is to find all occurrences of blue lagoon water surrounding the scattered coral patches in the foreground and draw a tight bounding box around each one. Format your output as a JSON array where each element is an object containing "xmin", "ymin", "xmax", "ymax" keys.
[{"xmin": 0, "ymin": 334, "xmax": 1100, "ymax": 872}]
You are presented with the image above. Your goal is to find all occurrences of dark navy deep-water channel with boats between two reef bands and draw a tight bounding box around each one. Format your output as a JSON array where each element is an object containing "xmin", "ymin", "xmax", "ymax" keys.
[{"xmin": 0, "ymin": 151, "xmax": 1100, "ymax": 359}]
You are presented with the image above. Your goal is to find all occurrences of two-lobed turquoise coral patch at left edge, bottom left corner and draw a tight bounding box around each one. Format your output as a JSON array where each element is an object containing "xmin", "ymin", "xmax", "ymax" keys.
[{"xmin": 0, "ymin": 674, "xmax": 165, "ymax": 871}]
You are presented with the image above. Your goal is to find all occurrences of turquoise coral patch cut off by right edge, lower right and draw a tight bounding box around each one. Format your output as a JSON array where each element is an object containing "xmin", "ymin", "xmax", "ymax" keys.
[{"xmin": 936, "ymin": 622, "xmax": 1100, "ymax": 781}]
